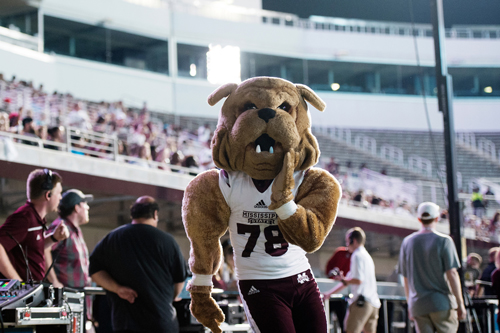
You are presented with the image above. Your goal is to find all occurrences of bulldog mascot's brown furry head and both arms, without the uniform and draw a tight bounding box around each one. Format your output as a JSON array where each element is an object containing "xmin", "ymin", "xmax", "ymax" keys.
[{"xmin": 182, "ymin": 77, "xmax": 341, "ymax": 333}]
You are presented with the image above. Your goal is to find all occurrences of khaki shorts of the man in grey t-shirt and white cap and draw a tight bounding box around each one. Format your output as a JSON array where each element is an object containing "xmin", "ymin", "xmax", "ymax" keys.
[{"xmin": 415, "ymin": 309, "xmax": 458, "ymax": 333}]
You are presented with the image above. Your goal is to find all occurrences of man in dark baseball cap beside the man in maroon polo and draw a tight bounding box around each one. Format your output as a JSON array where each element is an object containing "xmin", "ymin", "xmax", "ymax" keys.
[{"xmin": 45, "ymin": 189, "xmax": 94, "ymax": 324}]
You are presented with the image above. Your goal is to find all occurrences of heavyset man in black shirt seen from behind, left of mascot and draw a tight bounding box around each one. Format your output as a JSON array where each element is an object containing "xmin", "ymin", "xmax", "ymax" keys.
[{"xmin": 89, "ymin": 196, "xmax": 187, "ymax": 332}]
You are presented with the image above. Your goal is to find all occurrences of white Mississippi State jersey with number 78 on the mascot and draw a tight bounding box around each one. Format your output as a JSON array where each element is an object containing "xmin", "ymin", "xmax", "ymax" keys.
[{"xmin": 219, "ymin": 170, "xmax": 311, "ymax": 280}]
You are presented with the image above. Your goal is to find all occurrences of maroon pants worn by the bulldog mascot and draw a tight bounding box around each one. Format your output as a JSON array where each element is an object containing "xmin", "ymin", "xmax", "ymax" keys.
[{"xmin": 239, "ymin": 270, "xmax": 327, "ymax": 333}]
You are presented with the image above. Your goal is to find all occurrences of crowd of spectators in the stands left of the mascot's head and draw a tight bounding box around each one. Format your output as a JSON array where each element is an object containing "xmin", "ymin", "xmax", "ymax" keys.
[{"xmin": 0, "ymin": 74, "xmax": 213, "ymax": 173}]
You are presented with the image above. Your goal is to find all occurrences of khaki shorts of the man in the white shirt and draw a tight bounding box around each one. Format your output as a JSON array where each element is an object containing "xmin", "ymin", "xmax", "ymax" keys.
[{"xmin": 344, "ymin": 302, "xmax": 379, "ymax": 333}]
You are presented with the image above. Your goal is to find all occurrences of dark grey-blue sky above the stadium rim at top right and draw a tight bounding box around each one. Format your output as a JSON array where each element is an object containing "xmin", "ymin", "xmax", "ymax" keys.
[{"xmin": 262, "ymin": 0, "xmax": 500, "ymax": 27}]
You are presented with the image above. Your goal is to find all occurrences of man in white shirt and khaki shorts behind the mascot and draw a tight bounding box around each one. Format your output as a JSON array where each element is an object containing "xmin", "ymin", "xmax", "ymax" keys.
[{"xmin": 324, "ymin": 227, "xmax": 381, "ymax": 333}]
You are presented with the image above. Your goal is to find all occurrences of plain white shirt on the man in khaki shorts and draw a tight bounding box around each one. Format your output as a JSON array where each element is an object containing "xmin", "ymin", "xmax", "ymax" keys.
[{"xmin": 346, "ymin": 246, "xmax": 380, "ymax": 308}]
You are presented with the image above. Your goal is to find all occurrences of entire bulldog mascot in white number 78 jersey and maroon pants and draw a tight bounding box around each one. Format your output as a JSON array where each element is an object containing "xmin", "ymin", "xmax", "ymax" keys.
[{"xmin": 182, "ymin": 77, "xmax": 341, "ymax": 333}]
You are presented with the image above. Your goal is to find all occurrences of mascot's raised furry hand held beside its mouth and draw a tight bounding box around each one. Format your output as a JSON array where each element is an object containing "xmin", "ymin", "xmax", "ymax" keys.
[{"xmin": 269, "ymin": 150, "xmax": 300, "ymax": 210}]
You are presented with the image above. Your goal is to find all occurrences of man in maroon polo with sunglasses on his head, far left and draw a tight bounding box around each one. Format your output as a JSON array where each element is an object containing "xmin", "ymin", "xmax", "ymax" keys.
[{"xmin": 0, "ymin": 169, "xmax": 68, "ymax": 281}]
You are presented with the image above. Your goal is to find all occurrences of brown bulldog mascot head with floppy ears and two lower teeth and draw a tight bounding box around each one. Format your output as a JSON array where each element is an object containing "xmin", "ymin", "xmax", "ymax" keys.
[{"xmin": 208, "ymin": 77, "xmax": 325, "ymax": 180}]
